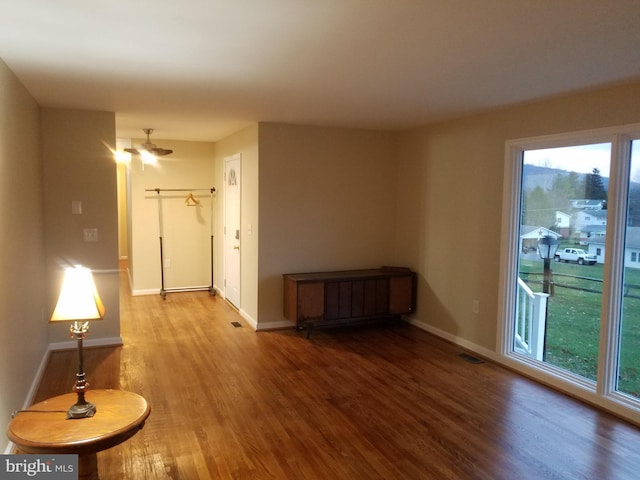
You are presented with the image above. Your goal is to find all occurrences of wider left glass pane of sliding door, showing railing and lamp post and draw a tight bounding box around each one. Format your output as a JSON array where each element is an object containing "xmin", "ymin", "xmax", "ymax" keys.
[{"xmin": 513, "ymin": 143, "xmax": 612, "ymax": 382}]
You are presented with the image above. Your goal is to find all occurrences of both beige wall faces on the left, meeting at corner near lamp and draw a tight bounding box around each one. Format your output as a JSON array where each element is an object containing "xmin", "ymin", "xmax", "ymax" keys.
[{"xmin": 0, "ymin": 61, "xmax": 120, "ymax": 451}]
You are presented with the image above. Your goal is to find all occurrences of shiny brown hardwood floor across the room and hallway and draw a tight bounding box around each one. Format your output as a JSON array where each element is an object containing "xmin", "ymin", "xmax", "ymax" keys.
[{"xmin": 31, "ymin": 268, "xmax": 640, "ymax": 480}]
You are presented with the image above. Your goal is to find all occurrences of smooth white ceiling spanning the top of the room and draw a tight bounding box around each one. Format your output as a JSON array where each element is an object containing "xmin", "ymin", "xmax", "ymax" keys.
[{"xmin": 0, "ymin": 0, "xmax": 640, "ymax": 141}]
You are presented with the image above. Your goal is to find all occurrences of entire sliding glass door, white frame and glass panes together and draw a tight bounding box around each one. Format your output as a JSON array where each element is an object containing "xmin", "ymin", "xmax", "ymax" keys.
[{"xmin": 501, "ymin": 126, "xmax": 640, "ymax": 415}]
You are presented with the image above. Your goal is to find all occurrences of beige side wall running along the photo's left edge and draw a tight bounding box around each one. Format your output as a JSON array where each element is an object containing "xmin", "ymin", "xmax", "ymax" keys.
[{"xmin": 0, "ymin": 60, "xmax": 49, "ymax": 453}]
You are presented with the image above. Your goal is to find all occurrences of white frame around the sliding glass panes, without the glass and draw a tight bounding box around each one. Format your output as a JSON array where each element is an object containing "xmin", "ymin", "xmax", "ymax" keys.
[{"xmin": 496, "ymin": 124, "xmax": 640, "ymax": 423}]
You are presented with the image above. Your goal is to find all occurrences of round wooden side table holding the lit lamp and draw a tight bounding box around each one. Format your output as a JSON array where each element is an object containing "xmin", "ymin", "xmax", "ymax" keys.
[{"xmin": 7, "ymin": 390, "xmax": 151, "ymax": 479}]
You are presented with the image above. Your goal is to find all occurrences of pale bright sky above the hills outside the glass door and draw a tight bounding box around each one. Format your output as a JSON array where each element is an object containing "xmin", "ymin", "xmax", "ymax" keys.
[{"xmin": 524, "ymin": 140, "xmax": 640, "ymax": 181}]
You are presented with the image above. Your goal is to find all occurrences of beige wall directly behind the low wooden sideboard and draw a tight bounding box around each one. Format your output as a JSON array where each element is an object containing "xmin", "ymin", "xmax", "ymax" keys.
[{"xmin": 258, "ymin": 123, "xmax": 397, "ymax": 328}]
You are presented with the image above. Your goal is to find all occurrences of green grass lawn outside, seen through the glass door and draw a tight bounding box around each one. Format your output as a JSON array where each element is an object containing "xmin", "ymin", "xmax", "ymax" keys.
[{"xmin": 520, "ymin": 260, "xmax": 640, "ymax": 398}]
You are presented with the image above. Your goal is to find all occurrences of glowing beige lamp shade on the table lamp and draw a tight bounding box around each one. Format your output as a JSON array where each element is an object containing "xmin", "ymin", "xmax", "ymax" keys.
[{"xmin": 49, "ymin": 266, "xmax": 105, "ymax": 322}]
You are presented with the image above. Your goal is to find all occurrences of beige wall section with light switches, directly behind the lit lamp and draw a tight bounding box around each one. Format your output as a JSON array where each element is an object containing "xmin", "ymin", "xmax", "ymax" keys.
[{"xmin": 42, "ymin": 108, "xmax": 120, "ymax": 343}]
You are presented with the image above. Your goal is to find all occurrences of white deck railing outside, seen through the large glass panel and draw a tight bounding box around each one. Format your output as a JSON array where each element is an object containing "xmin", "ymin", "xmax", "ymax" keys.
[{"xmin": 514, "ymin": 277, "xmax": 549, "ymax": 360}]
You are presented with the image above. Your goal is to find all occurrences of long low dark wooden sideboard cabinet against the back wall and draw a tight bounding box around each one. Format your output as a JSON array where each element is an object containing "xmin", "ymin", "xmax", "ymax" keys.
[{"xmin": 283, "ymin": 267, "xmax": 416, "ymax": 336}]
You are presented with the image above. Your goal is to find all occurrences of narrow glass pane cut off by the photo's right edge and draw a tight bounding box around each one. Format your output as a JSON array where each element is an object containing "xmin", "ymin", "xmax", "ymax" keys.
[{"xmin": 618, "ymin": 140, "xmax": 640, "ymax": 398}]
